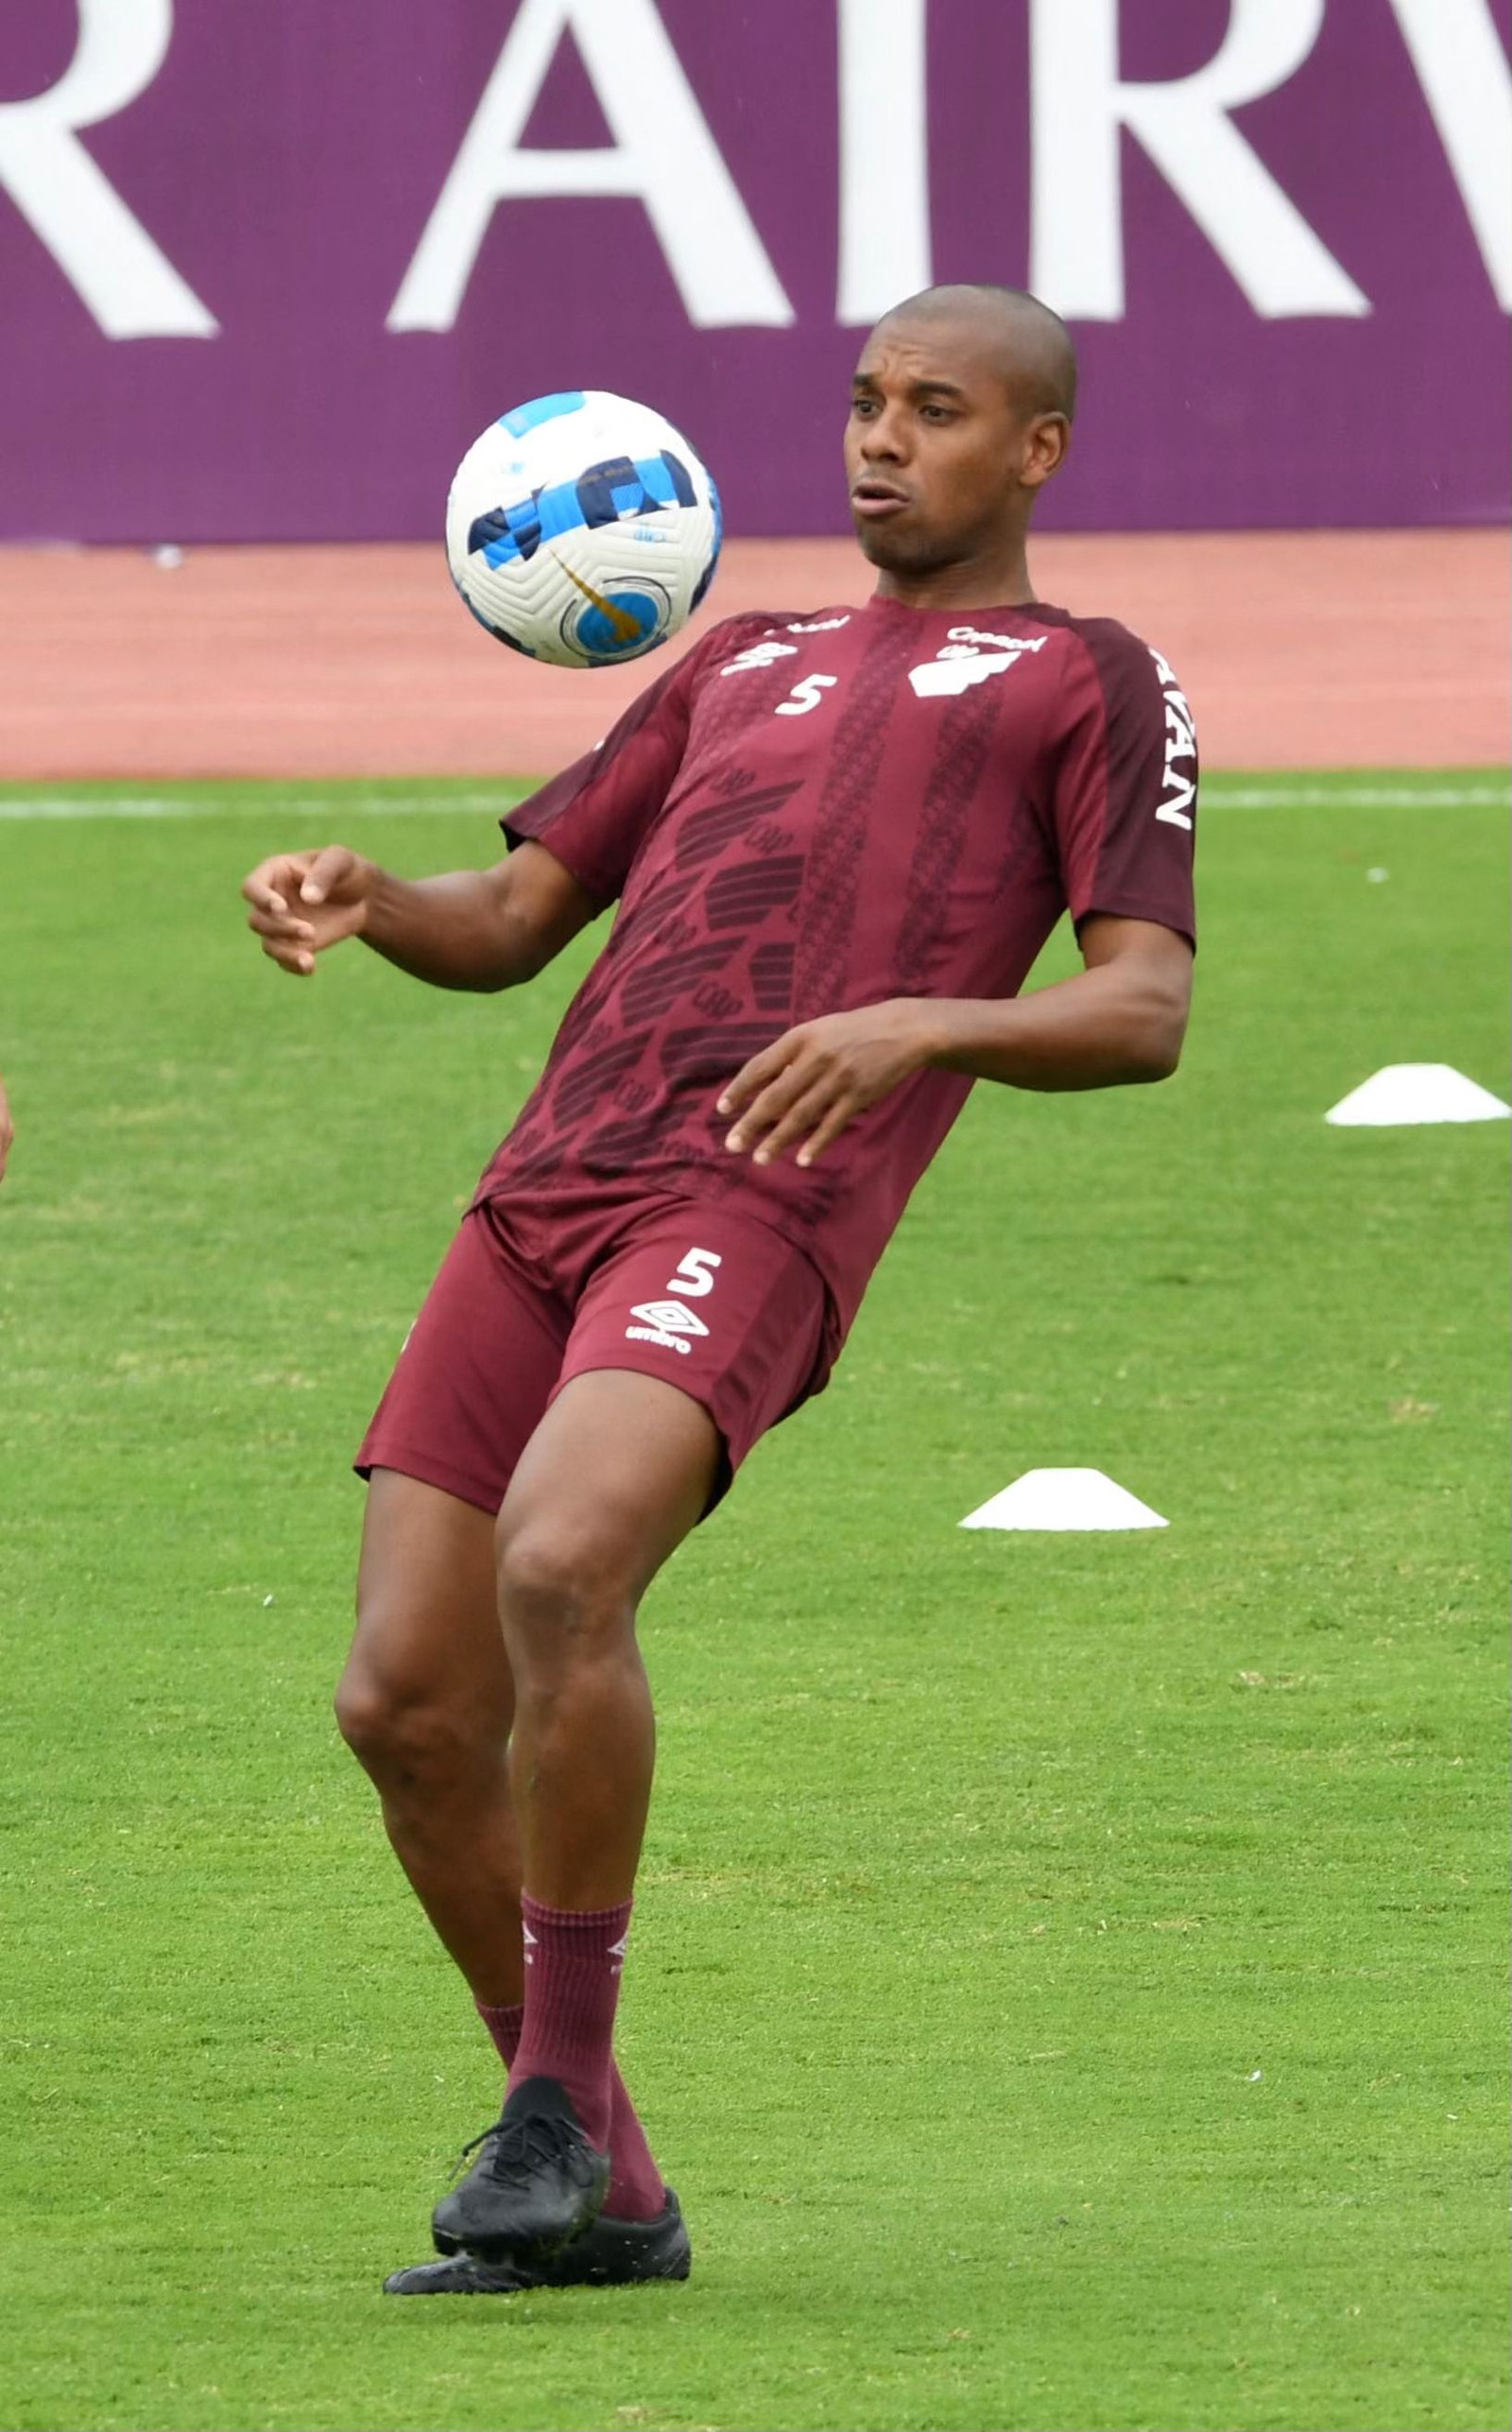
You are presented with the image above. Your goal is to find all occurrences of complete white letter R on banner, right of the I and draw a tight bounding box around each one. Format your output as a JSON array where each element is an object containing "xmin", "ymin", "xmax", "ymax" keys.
[{"xmin": 1028, "ymin": 0, "xmax": 1371, "ymax": 321}]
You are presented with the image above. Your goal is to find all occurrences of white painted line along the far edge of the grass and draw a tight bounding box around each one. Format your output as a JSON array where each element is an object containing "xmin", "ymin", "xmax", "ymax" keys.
[{"xmin": 0, "ymin": 778, "xmax": 1507, "ymax": 819}]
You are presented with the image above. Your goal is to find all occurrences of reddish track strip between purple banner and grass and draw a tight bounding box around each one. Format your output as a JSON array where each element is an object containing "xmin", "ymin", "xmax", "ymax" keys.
[{"xmin": 0, "ymin": 532, "xmax": 1509, "ymax": 781}]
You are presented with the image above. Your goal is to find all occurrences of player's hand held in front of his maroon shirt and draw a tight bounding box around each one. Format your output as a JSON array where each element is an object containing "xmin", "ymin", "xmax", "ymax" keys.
[{"xmin": 717, "ymin": 997, "xmax": 936, "ymax": 1164}]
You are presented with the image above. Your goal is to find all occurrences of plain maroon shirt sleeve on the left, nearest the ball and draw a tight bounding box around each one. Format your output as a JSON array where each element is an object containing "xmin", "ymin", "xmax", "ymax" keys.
[{"xmin": 498, "ymin": 628, "xmax": 719, "ymax": 905}]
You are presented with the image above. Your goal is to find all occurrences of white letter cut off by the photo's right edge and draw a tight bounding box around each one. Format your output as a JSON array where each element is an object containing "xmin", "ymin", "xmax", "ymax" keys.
[{"xmin": 1390, "ymin": 0, "xmax": 1512, "ymax": 311}]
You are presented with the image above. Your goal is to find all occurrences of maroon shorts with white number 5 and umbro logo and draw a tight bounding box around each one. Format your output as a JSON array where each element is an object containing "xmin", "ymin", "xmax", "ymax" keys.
[{"xmin": 355, "ymin": 1199, "xmax": 829, "ymax": 1512}]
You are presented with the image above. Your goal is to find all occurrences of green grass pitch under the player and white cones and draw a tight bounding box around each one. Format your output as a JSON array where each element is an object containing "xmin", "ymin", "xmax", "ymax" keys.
[{"xmin": 0, "ymin": 773, "xmax": 1507, "ymax": 2432}]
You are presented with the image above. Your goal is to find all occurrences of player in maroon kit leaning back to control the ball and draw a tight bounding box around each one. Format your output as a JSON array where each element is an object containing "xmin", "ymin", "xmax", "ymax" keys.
[{"xmin": 243, "ymin": 287, "xmax": 1196, "ymax": 2293}]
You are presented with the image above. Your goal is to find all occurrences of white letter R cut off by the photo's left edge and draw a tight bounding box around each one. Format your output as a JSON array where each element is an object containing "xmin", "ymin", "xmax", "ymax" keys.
[{"xmin": 0, "ymin": 0, "xmax": 216, "ymax": 338}]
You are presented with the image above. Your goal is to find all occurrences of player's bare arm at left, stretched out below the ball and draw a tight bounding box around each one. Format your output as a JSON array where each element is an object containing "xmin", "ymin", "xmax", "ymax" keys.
[{"xmin": 241, "ymin": 841, "xmax": 600, "ymax": 992}]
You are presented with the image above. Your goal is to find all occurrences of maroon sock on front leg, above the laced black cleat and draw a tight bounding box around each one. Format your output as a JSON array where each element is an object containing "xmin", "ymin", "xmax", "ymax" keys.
[{"xmin": 510, "ymin": 1892, "xmax": 629, "ymax": 2152}]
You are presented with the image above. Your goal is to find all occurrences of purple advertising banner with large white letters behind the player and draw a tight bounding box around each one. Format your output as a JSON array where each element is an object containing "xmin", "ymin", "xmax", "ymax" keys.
[{"xmin": 0, "ymin": 0, "xmax": 1512, "ymax": 543}]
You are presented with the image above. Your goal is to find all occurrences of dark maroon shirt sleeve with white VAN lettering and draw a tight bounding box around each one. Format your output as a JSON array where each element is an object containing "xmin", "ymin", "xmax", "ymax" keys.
[{"xmin": 1050, "ymin": 620, "xmax": 1196, "ymax": 946}]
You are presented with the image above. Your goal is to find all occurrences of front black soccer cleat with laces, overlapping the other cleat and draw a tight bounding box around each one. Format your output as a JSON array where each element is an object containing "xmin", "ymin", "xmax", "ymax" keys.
[{"xmin": 430, "ymin": 2077, "xmax": 610, "ymax": 2269}]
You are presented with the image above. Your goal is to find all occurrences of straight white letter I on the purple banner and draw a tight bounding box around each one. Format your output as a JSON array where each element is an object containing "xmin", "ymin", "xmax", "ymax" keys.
[{"xmin": 836, "ymin": 0, "xmax": 934, "ymax": 326}]
